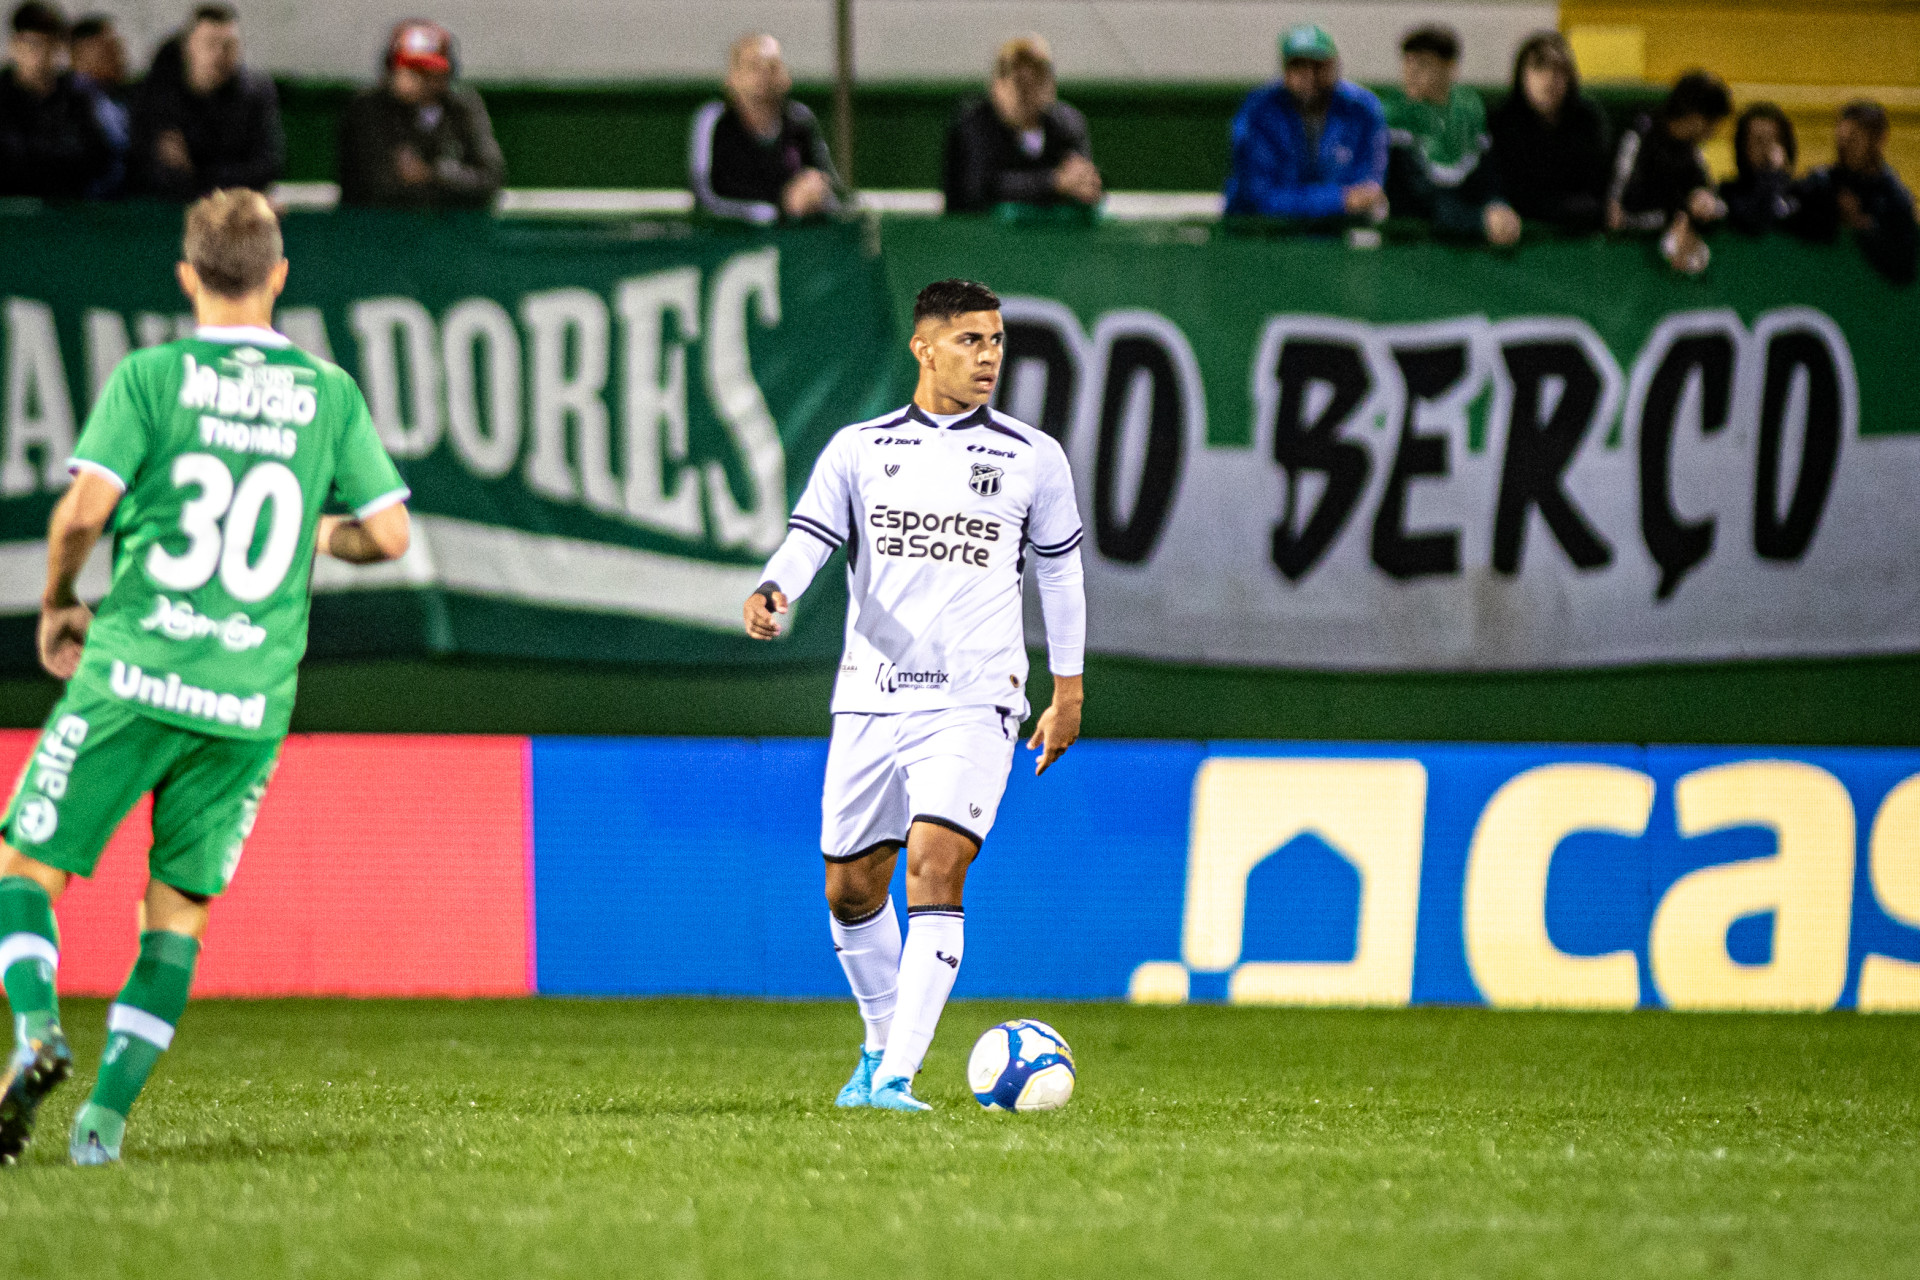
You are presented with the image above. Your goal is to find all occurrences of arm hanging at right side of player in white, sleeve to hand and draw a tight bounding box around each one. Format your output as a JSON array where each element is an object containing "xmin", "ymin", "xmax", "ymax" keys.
[{"xmin": 1027, "ymin": 445, "xmax": 1087, "ymax": 775}]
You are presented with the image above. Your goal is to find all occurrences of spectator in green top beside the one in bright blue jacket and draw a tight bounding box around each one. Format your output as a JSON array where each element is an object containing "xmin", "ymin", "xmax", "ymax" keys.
[{"xmin": 1380, "ymin": 27, "xmax": 1521, "ymax": 246}]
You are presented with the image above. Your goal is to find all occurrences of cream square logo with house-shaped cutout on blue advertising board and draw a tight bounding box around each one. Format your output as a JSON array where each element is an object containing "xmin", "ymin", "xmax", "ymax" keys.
[{"xmin": 1137, "ymin": 758, "xmax": 1427, "ymax": 1006}]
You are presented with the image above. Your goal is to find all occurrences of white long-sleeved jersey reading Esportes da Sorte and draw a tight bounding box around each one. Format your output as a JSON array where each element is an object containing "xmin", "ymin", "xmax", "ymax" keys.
[{"xmin": 766, "ymin": 405, "xmax": 1085, "ymax": 716}]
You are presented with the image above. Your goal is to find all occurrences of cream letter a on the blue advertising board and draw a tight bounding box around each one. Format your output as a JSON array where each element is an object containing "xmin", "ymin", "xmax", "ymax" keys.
[{"xmin": 1647, "ymin": 760, "xmax": 1853, "ymax": 1009}]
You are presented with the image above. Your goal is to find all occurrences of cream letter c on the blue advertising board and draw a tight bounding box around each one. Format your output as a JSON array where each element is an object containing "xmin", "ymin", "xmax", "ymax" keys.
[{"xmin": 1465, "ymin": 764, "xmax": 1653, "ymax": 1009}]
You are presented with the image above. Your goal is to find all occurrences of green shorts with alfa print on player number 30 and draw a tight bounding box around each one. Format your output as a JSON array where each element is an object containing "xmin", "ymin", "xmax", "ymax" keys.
[{"xmin": 0, "ymin": 689, "xmax": 280, "ymax": 894}]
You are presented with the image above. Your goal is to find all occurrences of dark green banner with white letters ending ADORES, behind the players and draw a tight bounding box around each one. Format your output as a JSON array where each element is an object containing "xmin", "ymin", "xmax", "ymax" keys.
[{"xmin": 0, "ymin": 209, "xmax": 895, "ymax": 662}]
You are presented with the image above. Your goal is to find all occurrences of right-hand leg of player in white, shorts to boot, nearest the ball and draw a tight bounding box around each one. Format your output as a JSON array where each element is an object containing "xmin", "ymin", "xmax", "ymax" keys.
[{"xmin": 874, "ymin": 706, "xmax": 1020, "ymax": 1111}]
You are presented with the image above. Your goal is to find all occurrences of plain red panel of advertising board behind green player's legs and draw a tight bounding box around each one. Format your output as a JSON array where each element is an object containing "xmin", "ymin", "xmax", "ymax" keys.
[{"xmin": 0, "ymin": 731, "xmax": 530, "ymax": 996}]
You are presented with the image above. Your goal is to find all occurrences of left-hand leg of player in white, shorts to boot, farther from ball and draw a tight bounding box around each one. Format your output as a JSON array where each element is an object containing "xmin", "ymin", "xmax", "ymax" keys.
[{"xmin": 820, "ymin": 716, "xmax": 906, "ymax": 1107}]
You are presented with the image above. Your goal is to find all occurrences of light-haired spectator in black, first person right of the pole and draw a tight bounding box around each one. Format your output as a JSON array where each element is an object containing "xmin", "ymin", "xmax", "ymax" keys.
[{"xmin": 945, "ymin": 36, "xmax": 1102, "ymax": 213}]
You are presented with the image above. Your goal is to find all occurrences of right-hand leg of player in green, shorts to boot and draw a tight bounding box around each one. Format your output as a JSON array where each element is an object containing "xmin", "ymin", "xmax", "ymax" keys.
[{"xmin": 69, "ymin": 731, "xmax": 280, "ymax": 1165}]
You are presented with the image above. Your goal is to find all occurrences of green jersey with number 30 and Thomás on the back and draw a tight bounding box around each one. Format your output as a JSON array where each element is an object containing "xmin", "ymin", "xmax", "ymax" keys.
[{"xmin": 71, "ymin": 328, "xmax": 407, "ymax": 739}]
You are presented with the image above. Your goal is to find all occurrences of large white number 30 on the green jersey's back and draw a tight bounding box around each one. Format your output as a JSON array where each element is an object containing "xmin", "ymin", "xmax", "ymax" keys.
[{"xmin": 146, "ymin": 453, "xmax": 307, "ymax": 604}]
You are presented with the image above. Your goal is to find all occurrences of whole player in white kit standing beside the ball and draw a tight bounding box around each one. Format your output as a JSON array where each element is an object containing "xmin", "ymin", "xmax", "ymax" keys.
[{"xmin": 745, "ymin": 280, "xmax": 1087, "ymax": 1111}]
